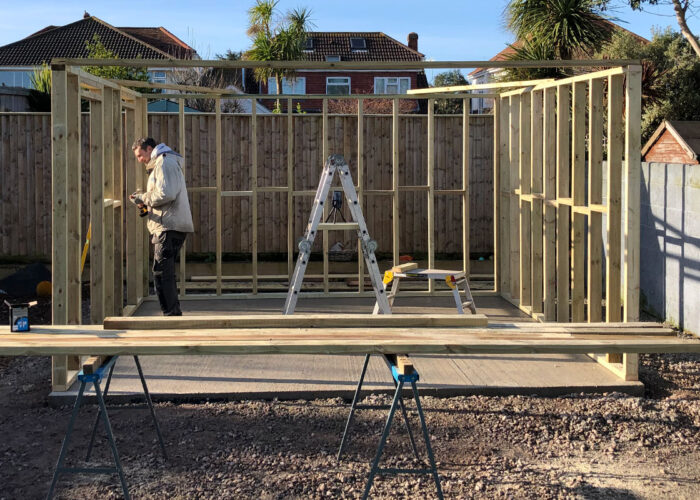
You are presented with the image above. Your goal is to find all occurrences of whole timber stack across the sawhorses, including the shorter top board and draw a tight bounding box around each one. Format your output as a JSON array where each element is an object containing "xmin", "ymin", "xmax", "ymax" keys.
[{"xmin": 0, "ymin": 315, "xmax": 700, "ymax": 355}]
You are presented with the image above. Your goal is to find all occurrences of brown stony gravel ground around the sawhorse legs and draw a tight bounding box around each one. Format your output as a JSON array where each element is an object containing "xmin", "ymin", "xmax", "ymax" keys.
[{"xmin": 0, "ymin": 294, "xmax": 700, "ymax": 500}]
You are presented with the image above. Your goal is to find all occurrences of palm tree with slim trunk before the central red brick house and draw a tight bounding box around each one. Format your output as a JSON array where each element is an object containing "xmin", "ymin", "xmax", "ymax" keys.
[{"xmin": 245, "ymin": 0, "xmax": 311, "ymax": 110}]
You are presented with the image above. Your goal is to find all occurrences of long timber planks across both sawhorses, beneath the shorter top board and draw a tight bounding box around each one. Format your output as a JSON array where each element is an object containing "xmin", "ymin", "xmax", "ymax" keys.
[{"xmin": 0, "ymin": 324, "xmax": 700, "ymax": 356}]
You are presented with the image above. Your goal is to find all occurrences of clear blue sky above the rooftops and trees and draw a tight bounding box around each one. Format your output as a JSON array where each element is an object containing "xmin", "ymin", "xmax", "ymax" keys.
[{"xmin": 0, "ymin": 0, "xmax": 700, "ymax": 79}]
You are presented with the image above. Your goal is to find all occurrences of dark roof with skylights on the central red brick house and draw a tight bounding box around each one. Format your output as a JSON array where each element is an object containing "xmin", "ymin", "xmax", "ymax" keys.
[{"xmin": 304, "ymin": 31, "xmax": 424, "ymax": 61}]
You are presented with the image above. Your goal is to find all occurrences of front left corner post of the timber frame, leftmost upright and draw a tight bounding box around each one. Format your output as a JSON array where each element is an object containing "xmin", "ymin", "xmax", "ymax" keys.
[{"xmin": 51, "ymin": 65, "xmax": 68, "ymax": 390}]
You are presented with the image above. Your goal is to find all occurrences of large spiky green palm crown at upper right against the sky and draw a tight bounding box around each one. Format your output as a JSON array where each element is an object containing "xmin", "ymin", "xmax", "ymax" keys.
[{"xmin": 504, "ymin": 0, "xmax": 611, "ymax": 59}]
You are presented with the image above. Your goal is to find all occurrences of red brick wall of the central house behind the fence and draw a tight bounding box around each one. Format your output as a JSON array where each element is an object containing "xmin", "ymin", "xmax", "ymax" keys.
[{"xmin": 260, "ymin": 71, "xmax": 418, "ymax": 111}]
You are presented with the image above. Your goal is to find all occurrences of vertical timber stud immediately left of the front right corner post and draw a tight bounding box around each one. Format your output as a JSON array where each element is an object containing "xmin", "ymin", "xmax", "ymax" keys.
[{"xmin": 605, "ymin": 75, "xmax": 624, "ymax": 323}]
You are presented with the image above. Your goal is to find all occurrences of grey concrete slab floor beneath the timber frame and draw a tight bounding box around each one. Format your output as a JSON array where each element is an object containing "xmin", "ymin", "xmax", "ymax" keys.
[{"xmin": 52, "ymin": 297, "xmax": 643, "ymax": 403}]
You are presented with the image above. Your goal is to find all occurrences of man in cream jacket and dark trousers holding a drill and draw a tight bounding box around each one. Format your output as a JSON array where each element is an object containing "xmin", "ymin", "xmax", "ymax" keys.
[{"xmin": 131, "ymin": 137, "xmax": 194, "ymax": 316}]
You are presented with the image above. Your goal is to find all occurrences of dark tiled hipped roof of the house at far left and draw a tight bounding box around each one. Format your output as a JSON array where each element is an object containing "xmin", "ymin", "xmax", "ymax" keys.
[{"xmin": 0, "ymin": 16, "xmax": 185, "ymax": 66}]
